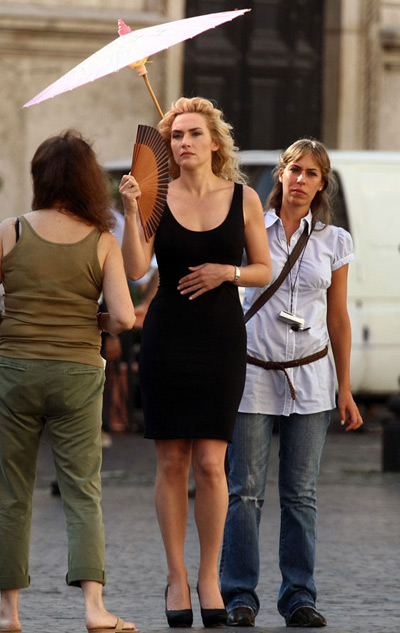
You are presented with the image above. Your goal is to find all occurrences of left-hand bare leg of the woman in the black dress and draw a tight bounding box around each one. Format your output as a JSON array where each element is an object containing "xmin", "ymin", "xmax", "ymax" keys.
[{"xmin": 155, "ymin": 439, "xmax": 192, "ymax": 610}]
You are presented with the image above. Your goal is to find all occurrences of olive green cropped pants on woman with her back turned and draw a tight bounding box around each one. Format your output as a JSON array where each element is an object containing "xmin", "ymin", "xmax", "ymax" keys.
[{"xmin": 0, "ymin": 356, "xmax": 105, "ymax": 589}]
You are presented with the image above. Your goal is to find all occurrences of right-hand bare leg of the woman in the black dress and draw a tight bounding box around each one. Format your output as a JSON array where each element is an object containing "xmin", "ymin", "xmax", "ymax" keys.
[{"xmin": 192, "ymin": 439, "xmax": 228, "ymax": 609}]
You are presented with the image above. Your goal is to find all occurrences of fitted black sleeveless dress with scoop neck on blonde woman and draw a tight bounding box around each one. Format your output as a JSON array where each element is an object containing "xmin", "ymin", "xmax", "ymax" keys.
[{"xmin": 139, "ymin": 184, "xmax": 246, "ymax": 442}]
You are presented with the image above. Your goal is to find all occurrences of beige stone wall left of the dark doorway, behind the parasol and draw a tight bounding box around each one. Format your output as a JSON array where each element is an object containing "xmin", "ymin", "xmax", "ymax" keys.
[{"xmin": 0, "ymin": 0, "xmax": 184, "ymax": 219}]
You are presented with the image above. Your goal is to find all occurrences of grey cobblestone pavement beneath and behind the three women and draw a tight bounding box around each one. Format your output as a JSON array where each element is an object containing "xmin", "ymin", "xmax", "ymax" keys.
[{"xmin": 13, "ymin": 414, "xmax": 400, "ymax": 633}]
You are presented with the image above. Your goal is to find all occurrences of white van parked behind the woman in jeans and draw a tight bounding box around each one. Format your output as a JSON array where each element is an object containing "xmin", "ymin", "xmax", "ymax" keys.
[{"xmin": 241, "ymin": 150, "xmax": 400, "ymax": 399}]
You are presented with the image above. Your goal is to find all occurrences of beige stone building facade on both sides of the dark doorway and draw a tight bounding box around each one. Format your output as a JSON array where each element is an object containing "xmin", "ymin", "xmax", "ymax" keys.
[{"xmin": 0, "ymin": 0, "xmax": 400, "ymax": 219}]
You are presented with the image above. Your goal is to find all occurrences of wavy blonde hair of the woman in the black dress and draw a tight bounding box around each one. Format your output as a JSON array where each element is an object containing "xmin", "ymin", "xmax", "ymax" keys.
[{"xmin": 157, "ymin": 97, "xmax": 247, "ymax": 184}]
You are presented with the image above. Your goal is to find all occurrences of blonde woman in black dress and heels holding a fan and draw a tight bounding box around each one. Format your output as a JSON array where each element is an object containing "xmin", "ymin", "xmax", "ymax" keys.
[{"xmin": 120, "ymin": 97, "xmax": 270, "ymax": 626}]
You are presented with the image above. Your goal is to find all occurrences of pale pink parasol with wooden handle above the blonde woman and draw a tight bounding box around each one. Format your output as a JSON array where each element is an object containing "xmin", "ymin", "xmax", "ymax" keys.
[{"xmin": 24, "ymin": 9, "xmax": 250, "ymax": 117}]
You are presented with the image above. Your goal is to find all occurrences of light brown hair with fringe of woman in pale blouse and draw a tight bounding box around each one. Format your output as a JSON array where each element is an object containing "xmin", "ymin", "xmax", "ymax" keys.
[{"xmin": 267, "ymin": 138, "xmax": 336, "ymax": 226}]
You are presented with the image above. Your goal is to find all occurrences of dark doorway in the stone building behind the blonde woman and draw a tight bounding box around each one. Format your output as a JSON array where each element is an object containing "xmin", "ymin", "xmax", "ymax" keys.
[{"xmin": 184, "ymin": 0, "xmax": 324, "ymax": 149}]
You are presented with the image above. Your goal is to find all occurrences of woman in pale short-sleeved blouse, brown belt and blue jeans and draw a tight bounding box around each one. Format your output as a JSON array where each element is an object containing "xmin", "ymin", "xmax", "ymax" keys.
[{"xmin": 221, "ymin": 139, "xmax": 363, "ymax": 627}]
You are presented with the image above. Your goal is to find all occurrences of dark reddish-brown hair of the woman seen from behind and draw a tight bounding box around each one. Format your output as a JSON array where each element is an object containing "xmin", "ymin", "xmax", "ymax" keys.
[{"xmin": 31, "ymin": 130, "xmax": 114, "ymax": 231}]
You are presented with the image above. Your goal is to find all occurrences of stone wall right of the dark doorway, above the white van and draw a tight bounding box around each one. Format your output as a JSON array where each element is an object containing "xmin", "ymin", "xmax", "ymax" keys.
[{"xmin": 323, "ymin": 0, "xmax": 400, "ymax": 150}]
